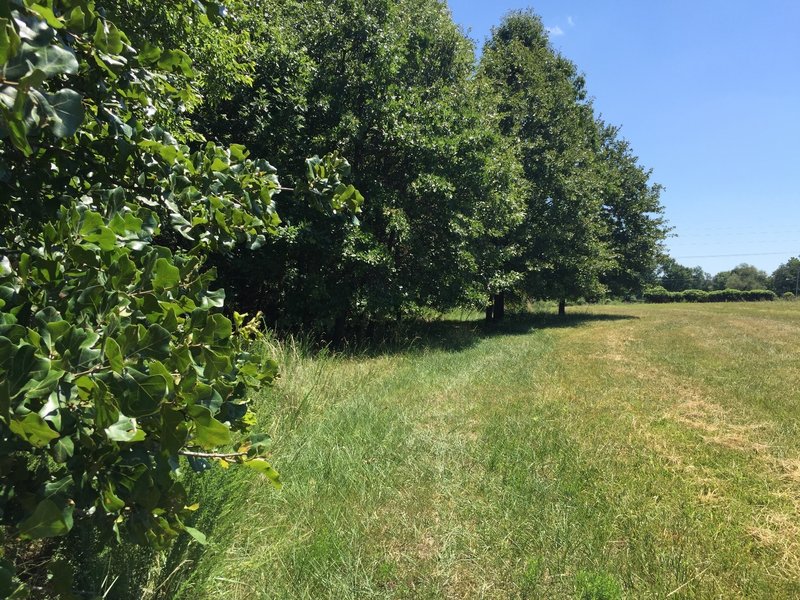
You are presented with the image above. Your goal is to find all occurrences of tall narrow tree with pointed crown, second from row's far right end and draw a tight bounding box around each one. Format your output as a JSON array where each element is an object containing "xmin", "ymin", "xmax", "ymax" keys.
[{"xmin": 480, "ymin": 11, "xmax": 613, "ymax": 313}]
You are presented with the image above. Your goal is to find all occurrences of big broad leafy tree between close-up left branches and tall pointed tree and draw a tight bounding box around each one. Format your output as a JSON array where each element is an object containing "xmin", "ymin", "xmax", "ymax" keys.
[{"xmin": 198, "ymin": 0, "xmax": 514, "ymax": 337}]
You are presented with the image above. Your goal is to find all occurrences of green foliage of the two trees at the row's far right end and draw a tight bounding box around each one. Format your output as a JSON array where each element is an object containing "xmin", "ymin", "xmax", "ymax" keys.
[{"xmin": 480, "ymin": 11, "xmax": 648, "ymax": 308}]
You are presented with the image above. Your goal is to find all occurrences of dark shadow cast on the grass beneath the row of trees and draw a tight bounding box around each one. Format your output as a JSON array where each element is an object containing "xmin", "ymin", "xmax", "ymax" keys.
[{"xmin": 338, "ymin": 313, "xmax": 639, "ymax": 357}]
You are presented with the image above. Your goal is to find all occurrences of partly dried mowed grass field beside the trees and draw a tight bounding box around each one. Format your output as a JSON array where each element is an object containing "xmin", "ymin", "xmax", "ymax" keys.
[{"xmin": 142, "ymin": 302, "xmax": 800, "ymax": 600}]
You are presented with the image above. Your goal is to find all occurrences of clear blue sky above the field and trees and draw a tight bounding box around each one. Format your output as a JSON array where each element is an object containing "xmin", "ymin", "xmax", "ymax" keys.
[{"xmin": 448, "ymin": 0, "xmax": 800, "ymax": 274}]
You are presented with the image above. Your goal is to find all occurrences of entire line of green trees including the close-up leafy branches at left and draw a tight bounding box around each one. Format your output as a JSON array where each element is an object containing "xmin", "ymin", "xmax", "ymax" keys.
[{"xmin": 0, "ymin": 0, "xmax": 666, "ymax": 598}]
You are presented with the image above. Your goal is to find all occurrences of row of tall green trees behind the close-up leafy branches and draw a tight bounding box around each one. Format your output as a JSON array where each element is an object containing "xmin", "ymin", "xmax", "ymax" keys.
[{"xmin": 183, "ymin": 0, "xmax": 665, "ymax": 330}]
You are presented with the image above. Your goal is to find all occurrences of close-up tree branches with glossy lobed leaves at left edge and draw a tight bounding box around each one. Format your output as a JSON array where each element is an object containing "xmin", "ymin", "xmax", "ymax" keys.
[{"xmin": 0, "ymin": 0, "xmax": 358, "ymax": 597}]
